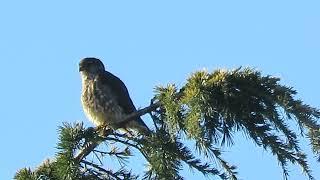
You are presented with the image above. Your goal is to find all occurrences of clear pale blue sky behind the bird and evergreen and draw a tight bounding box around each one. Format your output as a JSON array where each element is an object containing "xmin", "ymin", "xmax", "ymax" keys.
[{"xmin": 0, "ymin": 0, "xmax": 320, "ymax": 180}]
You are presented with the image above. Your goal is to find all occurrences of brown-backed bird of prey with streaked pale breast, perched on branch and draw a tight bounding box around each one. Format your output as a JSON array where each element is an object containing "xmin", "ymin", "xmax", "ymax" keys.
[{"xmin": 79, "ymin": 58, "xmax": 150, "ymax": 134}]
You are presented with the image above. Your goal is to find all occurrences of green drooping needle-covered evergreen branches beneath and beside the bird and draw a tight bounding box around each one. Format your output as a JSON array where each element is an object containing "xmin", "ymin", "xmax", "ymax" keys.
[{"xmin": 15, "ymin": 68, "xmax": 320, "ymax": 180}]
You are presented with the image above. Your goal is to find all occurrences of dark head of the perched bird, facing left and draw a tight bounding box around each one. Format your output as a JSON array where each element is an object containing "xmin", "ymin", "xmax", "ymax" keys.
[{"xmin": 79, "ymin": 57, "xmax": 105, "ymax": 75}]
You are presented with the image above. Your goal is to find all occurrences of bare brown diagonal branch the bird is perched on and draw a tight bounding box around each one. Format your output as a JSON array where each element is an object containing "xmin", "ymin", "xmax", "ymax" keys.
[{"xmin": 74, "ymin": 102, "xmax": 161, "ymax": 163}]
